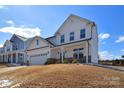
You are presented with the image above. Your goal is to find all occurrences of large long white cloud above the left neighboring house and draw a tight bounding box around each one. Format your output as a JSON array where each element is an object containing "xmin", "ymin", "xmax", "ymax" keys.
[{"xmin": 0, "ymin": 26, "xmax": 41, "ymax": 37}]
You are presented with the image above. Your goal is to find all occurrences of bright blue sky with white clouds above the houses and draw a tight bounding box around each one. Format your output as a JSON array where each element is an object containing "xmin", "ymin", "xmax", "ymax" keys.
[{"xmin": 0, "ymin": 5, "xmax": 124, "ymax": 59}]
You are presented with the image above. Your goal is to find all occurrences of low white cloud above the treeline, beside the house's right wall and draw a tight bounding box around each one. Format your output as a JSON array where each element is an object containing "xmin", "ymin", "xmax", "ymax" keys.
[{"xmin": 99, "ymin": 51, "xmax": 115, "ymax": 60}]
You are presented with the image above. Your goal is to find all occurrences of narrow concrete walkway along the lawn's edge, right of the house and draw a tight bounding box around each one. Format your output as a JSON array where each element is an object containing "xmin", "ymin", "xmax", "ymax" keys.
[{"xmin": 88, "ymin": 63, "xmax": 124, "ymax": 72}]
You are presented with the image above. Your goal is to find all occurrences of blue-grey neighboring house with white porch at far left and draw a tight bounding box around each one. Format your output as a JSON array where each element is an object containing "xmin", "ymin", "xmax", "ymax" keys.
[{"xmin": 0, "ymin": 34, "xmax": 31, "ymax": 64}]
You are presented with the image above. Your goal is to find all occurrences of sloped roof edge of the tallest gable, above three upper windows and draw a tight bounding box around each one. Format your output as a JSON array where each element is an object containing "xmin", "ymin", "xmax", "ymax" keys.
[{"xmin": 54, "ymin": 14, "xmax": 93, "ymax": 35}]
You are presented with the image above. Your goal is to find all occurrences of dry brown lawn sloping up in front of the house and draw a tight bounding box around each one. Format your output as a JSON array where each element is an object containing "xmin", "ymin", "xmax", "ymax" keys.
[{"xmin": 0, "ymin": 64, "xmax": 124, "ymax": 88}]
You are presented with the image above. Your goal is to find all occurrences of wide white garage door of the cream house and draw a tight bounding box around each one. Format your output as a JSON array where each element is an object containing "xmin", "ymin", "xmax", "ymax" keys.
[{"xmin": 30, "ymin": 54, "xmax": 47, "ymax": 65}]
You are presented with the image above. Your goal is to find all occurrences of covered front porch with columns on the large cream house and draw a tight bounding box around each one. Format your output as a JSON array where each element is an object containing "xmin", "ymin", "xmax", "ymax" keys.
[{"xmin": 51, "ymin": 41, "xmax": 91, "ymax": 63}]
